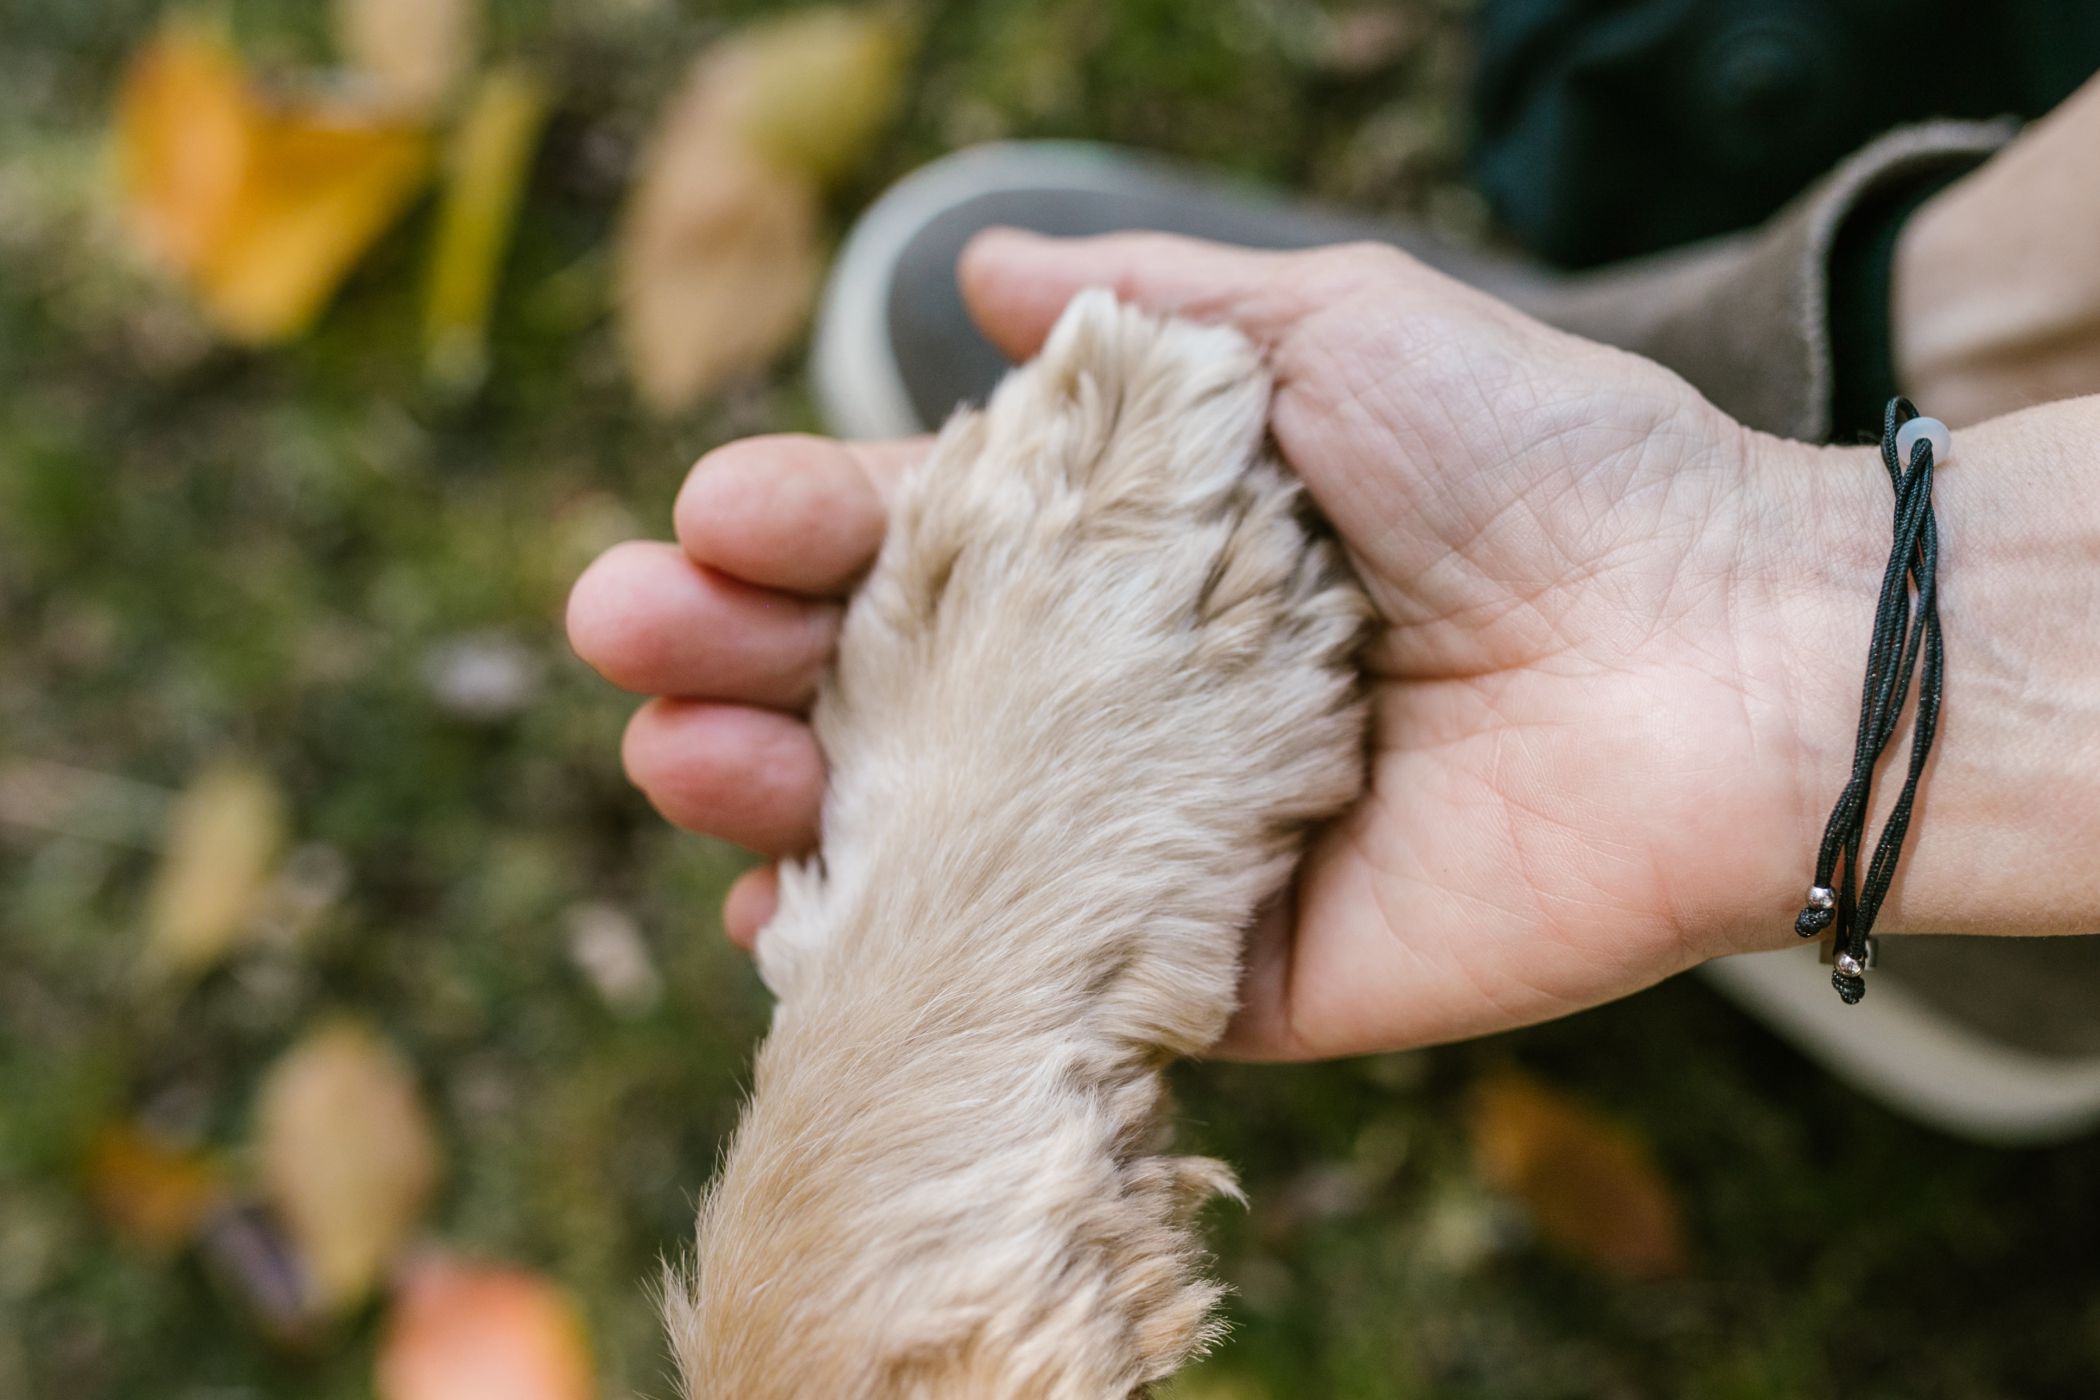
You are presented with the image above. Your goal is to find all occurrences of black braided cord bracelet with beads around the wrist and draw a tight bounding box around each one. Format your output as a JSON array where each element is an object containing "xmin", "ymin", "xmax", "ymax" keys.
[{"xmin": 1793, "ymin": 399, "xmax": 1951, "ymax": 1005}]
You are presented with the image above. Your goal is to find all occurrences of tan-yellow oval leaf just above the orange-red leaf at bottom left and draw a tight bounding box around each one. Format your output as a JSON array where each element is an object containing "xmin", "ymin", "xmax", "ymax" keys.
[{"xmin": 254, "ymin": 1020, "xmax": 439, "ymax": 1314}]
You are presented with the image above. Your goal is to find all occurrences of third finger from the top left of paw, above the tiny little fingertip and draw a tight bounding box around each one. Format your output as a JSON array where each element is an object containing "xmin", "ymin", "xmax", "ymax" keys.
[{"xmin": 620, "ymin": 699, "xmax": 823, "ymax": 856}]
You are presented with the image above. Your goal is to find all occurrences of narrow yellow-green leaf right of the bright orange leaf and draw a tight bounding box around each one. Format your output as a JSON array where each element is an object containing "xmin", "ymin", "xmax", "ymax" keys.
[{"xmin": 422, "ymin": 67, "xmax": 546, "ymax": 388}]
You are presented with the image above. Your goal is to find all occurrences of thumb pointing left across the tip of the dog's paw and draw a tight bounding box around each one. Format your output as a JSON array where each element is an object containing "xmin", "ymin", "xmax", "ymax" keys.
[{"xmin": 956, "ymin": 229, "xmax": 1360, "ymax": 359}]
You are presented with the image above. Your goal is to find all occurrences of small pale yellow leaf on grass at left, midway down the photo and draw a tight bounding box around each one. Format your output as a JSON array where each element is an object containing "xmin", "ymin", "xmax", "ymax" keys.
[{"xmin": 147, "ymin": 760, "xmax": 286, "ymax": 976}]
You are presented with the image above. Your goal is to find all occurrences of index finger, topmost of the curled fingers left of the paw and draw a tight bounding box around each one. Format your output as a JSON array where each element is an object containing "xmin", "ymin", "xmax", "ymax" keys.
[{"xmin": 672, "ymin": 434, "xmax": 926, "ymax": 594}]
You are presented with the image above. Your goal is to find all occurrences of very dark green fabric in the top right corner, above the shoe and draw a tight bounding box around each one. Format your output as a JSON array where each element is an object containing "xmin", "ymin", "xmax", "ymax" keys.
[{"xmin": 1472, "ymin": 0, "xmax": 2100, "ymax": 267}]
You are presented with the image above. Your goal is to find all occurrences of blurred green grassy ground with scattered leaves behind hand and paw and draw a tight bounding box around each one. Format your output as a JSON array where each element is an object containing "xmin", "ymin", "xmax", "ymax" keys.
[{"xmin": 0, "ymin": 0, "xmax": 2100, "ymax": 1400}]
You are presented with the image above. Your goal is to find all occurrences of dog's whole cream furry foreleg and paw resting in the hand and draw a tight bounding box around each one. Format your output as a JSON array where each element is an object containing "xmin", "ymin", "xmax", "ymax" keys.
[{"xmin": 668, "ymin": 292, "xmax": 1365, "ymax": 1400}]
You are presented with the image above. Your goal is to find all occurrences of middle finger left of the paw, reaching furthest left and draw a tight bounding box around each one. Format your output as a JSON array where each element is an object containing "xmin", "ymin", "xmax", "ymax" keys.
[{"xmin": 569, "ymin": 539, "xmax": 840, "ymax": 705}]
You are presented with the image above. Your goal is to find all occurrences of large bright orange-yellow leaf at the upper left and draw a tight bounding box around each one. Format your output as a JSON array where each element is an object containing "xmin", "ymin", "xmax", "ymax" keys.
[{"xmin": 118, "ymin": 27, "xmax": 431, "ymax": 342}]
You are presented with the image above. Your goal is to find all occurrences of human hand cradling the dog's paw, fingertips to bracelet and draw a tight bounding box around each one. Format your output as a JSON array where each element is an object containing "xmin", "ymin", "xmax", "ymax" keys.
[{"xmin": 569, "ymin": 231, "xmax": 1931, "ymax": 1058}]
